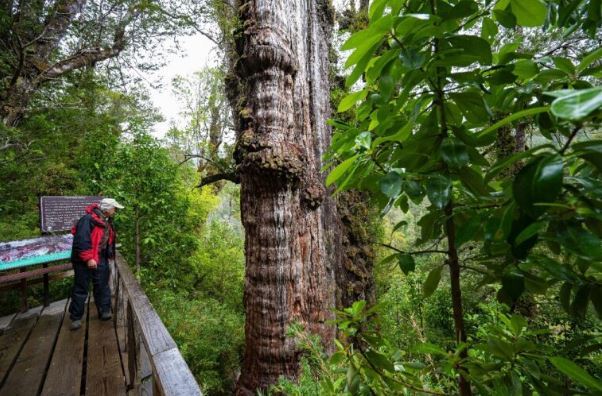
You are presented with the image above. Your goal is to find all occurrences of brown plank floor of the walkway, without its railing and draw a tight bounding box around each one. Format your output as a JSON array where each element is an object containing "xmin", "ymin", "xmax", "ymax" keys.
[{"xmin": 0, "ymin": 300, "xmax": 127, "ymax": 396}]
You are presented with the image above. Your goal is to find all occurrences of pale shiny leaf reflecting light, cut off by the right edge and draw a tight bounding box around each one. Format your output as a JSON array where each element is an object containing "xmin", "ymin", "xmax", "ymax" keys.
[{"xmin": 551, "ymin": 87, "xmax": 602, "ymax": 120}]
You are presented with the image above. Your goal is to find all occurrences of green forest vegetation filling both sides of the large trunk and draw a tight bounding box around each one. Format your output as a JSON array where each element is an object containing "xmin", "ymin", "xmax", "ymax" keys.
[{"xmin": 0, "ymin": 0, "xmax": 602, "ymax": 395}]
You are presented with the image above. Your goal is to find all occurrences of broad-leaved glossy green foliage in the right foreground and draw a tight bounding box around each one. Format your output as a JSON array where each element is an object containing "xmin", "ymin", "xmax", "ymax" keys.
[{"xmin": 327, "ymin": 0, "xmax": 602, "ymax": 394}]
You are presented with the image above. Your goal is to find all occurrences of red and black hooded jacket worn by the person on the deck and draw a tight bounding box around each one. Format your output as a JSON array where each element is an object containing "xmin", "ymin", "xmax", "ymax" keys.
[{"xmin": 71, "ymin": 204, "xmax": 115, "ymax": 263}]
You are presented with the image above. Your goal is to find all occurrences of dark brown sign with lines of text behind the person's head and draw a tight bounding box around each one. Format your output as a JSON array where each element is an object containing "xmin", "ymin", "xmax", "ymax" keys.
[{"xmin": 40, "ymin": 196, "xmax": 102, "ymax": 233}]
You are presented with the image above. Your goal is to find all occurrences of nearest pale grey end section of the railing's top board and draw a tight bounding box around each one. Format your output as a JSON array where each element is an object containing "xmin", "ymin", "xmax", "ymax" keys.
[{"xmin": 152, "ymin": 348, "xmax": 202, "ymax": 396}]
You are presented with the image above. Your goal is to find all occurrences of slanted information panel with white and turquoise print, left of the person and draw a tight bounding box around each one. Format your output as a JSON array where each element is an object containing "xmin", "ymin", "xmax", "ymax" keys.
[{"xmin": 0, "ymin": 234, "xmax": 73, "ymax": 271}]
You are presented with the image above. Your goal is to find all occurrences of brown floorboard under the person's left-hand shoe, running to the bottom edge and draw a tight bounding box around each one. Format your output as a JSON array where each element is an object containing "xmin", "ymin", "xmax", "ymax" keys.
[{"xmin": 42, "ymin": 296, "xmax": 88, "ymax": 396}]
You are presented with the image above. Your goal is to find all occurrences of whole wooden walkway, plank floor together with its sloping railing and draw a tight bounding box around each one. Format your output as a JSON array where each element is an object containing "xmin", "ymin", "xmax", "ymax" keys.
[{"xmin": 0, "ymin": 253, "xmax": 202, "ymax": 396}]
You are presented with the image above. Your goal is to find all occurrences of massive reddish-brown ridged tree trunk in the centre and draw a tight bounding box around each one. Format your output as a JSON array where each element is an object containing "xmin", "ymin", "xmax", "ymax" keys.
[{"xmin": 235, "ymin": 0, "xmax": 340, "ymax": 394}]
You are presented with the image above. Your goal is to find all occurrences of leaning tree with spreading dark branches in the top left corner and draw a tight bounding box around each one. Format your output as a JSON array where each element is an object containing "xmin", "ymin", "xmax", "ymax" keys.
[{"xmin": 0, "ymin": 0, "xmax": 216, "ymax": 126}]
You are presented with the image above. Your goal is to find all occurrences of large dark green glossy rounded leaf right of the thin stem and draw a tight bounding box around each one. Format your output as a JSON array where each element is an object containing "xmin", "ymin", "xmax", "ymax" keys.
[{"xmin": 512, "ymin": 155, "xmax": 563, "ymax": 217}]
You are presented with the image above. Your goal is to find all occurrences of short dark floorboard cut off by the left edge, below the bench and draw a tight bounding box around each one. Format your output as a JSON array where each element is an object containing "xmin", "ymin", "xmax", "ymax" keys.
[{"xmin": 0, "ymin": 307, "xmax": 42, "ymax": 391}]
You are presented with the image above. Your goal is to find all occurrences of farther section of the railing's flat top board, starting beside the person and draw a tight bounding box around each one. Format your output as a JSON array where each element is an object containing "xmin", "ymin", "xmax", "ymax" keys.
[{"xmin": 115, "ymin": 254, "xmax": 176, "ymax": 356}]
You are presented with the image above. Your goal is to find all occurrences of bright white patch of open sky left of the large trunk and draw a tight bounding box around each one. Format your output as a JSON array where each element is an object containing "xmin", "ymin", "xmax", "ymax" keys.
[{"xmin": 148, "ymin": 34, "xmax": 216, "ymax": 138}]
